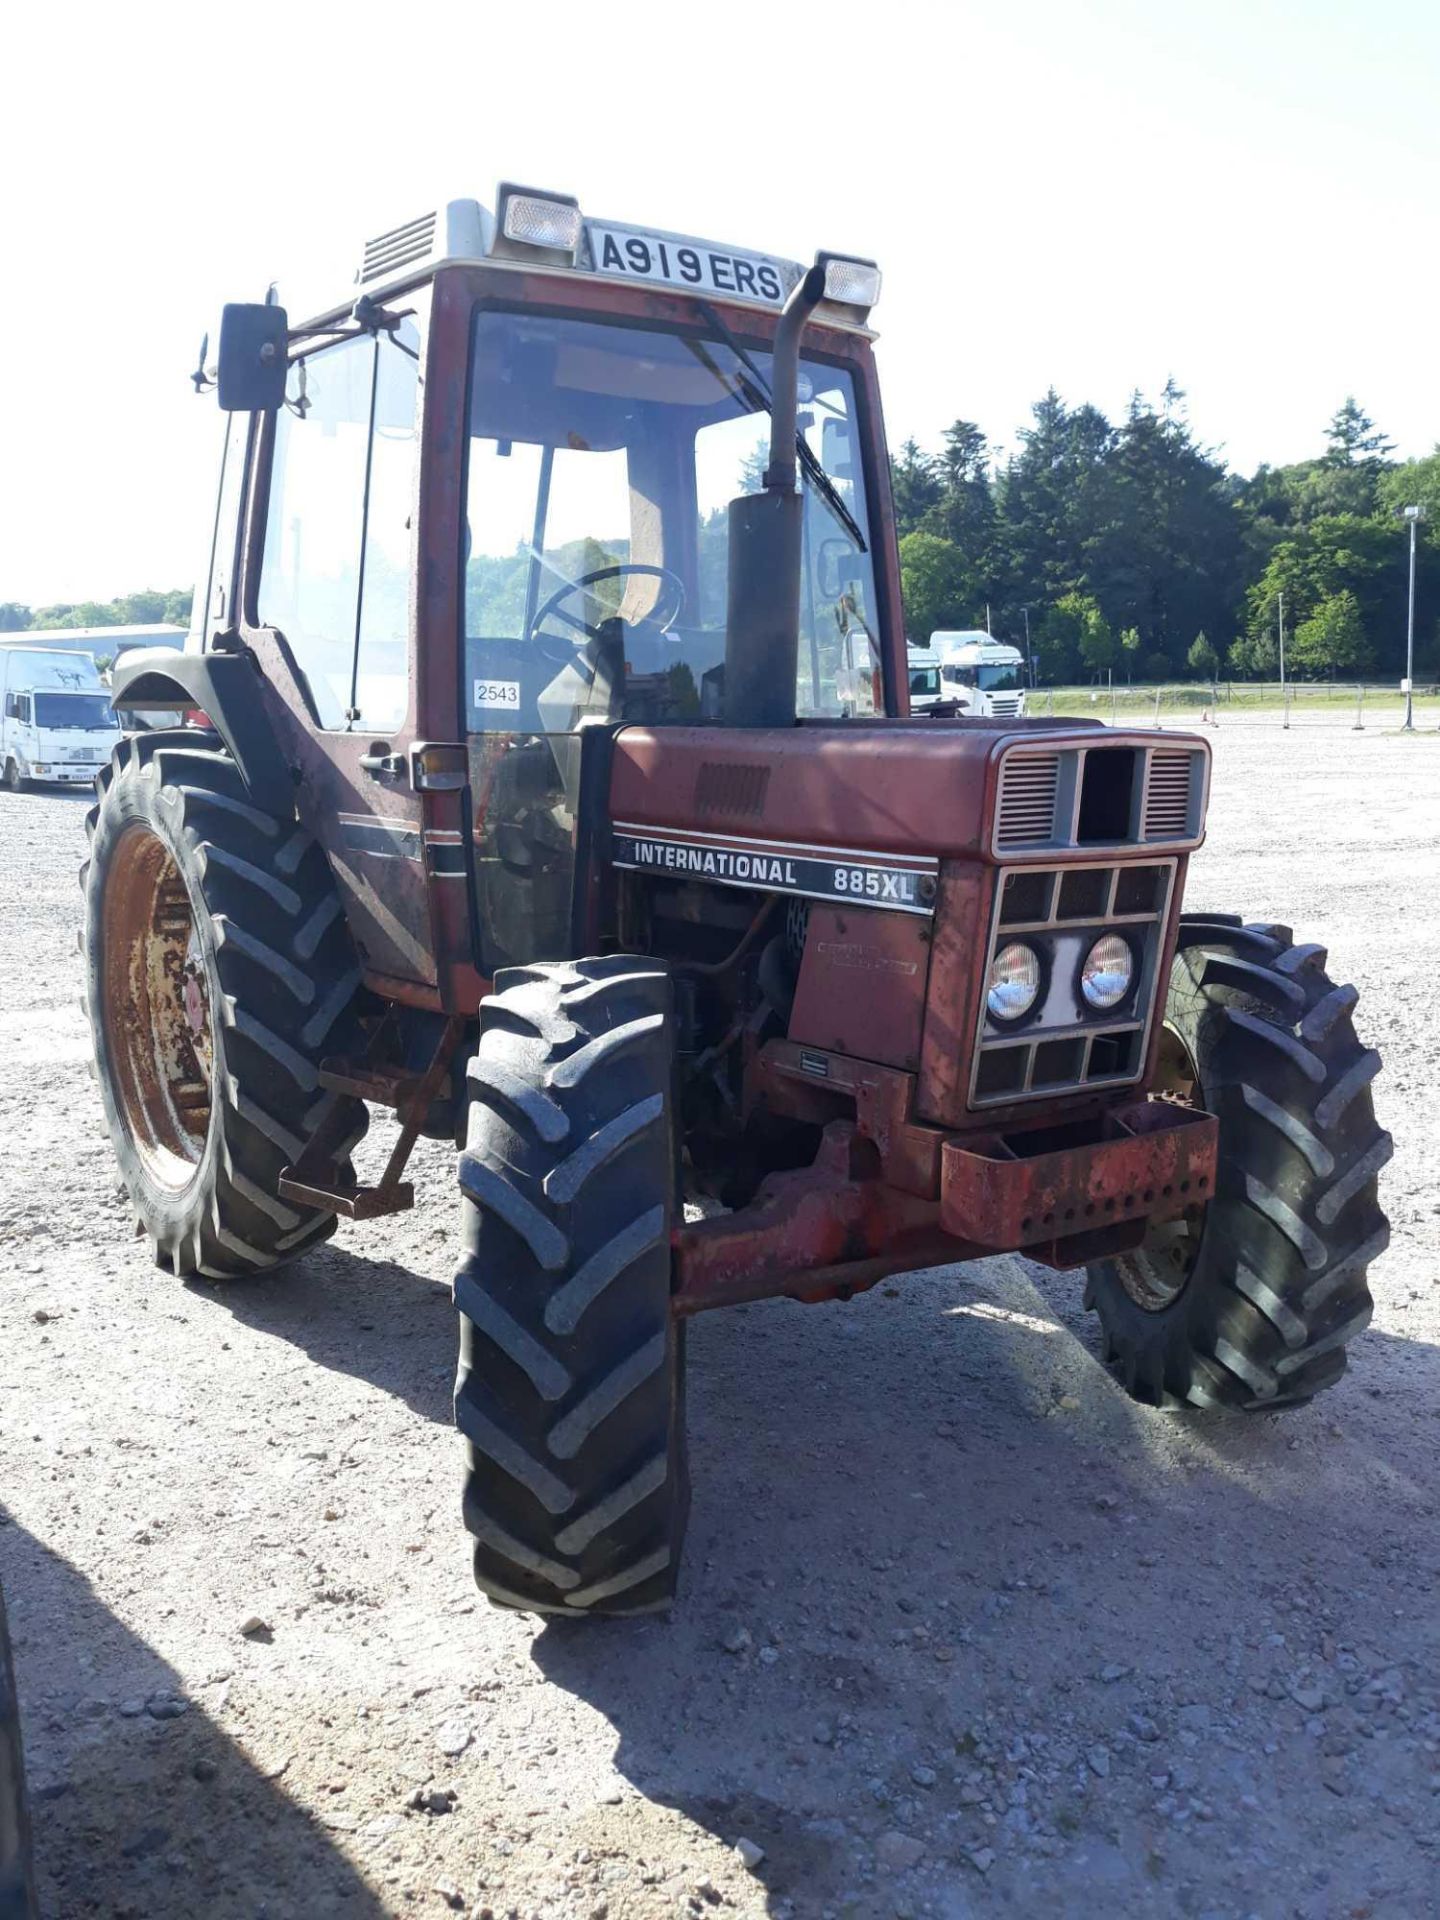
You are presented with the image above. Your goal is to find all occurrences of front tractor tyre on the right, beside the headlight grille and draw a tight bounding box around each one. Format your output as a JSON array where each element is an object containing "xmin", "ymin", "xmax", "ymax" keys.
[{"xmin": 1085, "ymin": 914, "xmax": 1392, "ymax": 1413}]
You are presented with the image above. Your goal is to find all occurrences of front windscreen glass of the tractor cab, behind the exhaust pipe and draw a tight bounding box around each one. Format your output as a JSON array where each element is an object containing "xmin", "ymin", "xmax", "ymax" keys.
[{"xmin": 465, "ymin": 311, "xmax": 883, "ymax": 733}]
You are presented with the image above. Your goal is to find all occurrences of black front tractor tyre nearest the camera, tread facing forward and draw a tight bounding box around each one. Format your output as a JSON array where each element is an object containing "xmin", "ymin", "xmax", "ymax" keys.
[{"xmin": 455, "ymin": 956, "xmax": 689, "ymax": 1617}]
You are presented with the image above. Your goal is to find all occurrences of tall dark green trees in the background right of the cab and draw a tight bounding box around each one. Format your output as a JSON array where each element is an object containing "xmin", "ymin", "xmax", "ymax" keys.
[{"xmin": 891, "ymin": 382, "xmax": 1440, "ymax": 684}]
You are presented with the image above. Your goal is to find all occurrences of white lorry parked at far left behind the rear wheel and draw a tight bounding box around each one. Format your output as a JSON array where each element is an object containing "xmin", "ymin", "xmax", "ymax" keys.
[{"xmin": 0, "ymin": 643, "xmax": 121, "ymax": 793}]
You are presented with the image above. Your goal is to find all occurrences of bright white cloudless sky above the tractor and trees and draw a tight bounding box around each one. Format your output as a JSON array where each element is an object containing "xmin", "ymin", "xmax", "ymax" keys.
[{"xmin": 0, "ymin": 0, "xmax": 1440, "ymax": 605}]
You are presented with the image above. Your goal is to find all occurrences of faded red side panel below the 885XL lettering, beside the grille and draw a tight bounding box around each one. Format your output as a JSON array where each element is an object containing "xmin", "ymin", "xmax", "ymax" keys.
[{"xmin": 789, "ymin": 902, "xmax": 929, "ymax": 1071}]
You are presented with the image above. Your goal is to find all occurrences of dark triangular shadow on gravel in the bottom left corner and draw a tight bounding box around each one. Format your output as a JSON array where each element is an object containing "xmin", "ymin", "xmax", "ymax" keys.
[{"xmin": 0, "ymin": 1509, "xmax": 386, "ymax": 1920}]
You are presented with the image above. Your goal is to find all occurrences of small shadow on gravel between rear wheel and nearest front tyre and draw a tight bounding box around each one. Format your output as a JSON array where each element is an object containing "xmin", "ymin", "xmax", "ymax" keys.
[{"xmin": 186, "ymin": 1246, "xmax": 457, "ymax": 1427}]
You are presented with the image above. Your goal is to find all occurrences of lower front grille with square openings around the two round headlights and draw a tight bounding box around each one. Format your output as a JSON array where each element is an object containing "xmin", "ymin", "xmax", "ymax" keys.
[{"xmin": 970, "ymin": 860, "xmax": 1175, "ymax": 1108}]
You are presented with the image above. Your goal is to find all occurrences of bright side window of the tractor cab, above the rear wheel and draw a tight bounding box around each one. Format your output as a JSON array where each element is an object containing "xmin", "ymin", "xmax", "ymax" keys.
[{"xmin": 257, "ymin": 321, "xmax": 419, "ymax": 732}]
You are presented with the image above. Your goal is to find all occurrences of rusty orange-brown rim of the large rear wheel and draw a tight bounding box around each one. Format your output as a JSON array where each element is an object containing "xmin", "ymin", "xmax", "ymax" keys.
[{"xmin": 102, "ymin": 826, "xmax": 215, "ymax": 1192}]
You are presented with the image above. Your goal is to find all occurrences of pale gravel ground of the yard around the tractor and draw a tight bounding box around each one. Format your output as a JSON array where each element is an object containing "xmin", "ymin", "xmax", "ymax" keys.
[{"xmin": 0, "ymin": 728, "xmax": 1440, "ymax": 1920}]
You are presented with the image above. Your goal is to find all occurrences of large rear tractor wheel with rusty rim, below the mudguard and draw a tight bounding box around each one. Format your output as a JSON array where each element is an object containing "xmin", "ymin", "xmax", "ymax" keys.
[{"xmin": 81, "ymin": 730, "xmax": 367, "ymax": 1281}]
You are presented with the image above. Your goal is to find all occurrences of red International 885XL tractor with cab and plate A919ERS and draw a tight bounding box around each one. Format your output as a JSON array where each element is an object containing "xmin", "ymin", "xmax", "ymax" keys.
[{"xmin": 84, "ymin": 186, "xmax": 1388, "ymax": 1615}]
